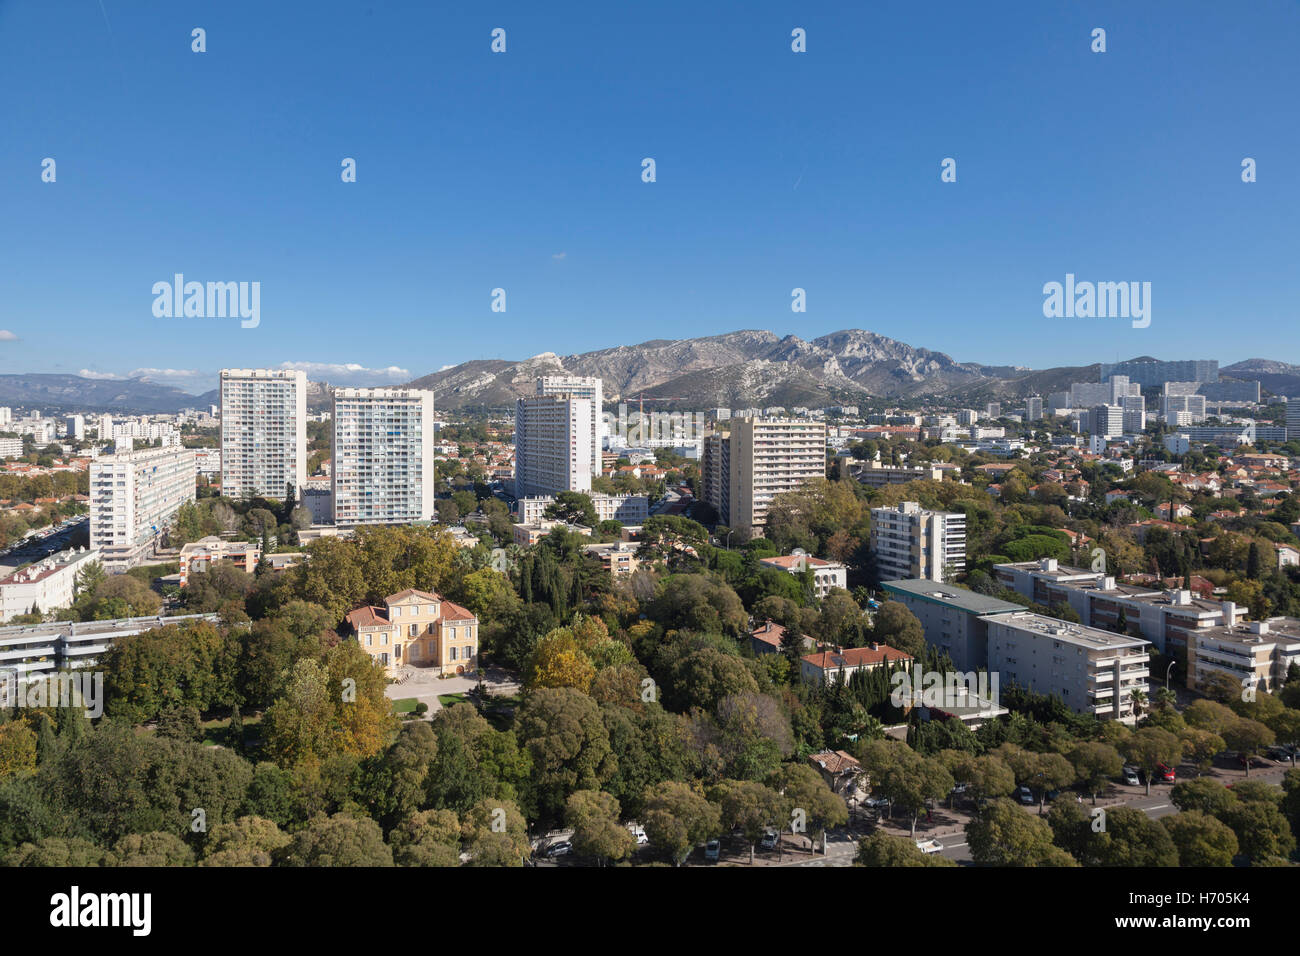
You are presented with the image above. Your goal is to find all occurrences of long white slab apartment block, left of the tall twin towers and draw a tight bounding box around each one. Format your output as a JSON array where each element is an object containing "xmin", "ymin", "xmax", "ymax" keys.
[{"xmin": 90, "ymin": 447, "xmax": 195, "ymax": 571}]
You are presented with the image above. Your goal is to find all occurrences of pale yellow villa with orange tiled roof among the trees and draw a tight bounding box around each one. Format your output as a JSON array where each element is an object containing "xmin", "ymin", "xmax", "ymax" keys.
[{"xmin": 347, "ymin": 588, "xmax": 478, "ymax": 675}]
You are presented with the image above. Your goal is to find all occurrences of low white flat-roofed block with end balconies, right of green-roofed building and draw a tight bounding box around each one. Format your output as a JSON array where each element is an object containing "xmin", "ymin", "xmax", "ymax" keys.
[{"xmin": 985, "ymin": 611, "xmax": 1151, "ymax": 724}]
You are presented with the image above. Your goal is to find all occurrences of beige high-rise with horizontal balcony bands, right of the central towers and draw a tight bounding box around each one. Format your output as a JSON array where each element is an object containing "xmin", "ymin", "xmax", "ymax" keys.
[{"xmin": 728, "ymin": 418, "xmax": 826, "ymax": 540}]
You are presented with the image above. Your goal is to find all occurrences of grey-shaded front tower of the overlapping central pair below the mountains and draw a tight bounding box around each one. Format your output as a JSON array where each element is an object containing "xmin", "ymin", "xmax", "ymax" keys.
[{"xmin": 515, "ymin": 394, "xmax": 599, "ymax": 498}]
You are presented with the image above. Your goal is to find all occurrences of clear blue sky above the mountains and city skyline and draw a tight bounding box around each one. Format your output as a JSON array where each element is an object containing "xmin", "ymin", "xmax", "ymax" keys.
[{"xmin": 0, "ymin": 0, "xmax": 1300, "ymax": 392}]
